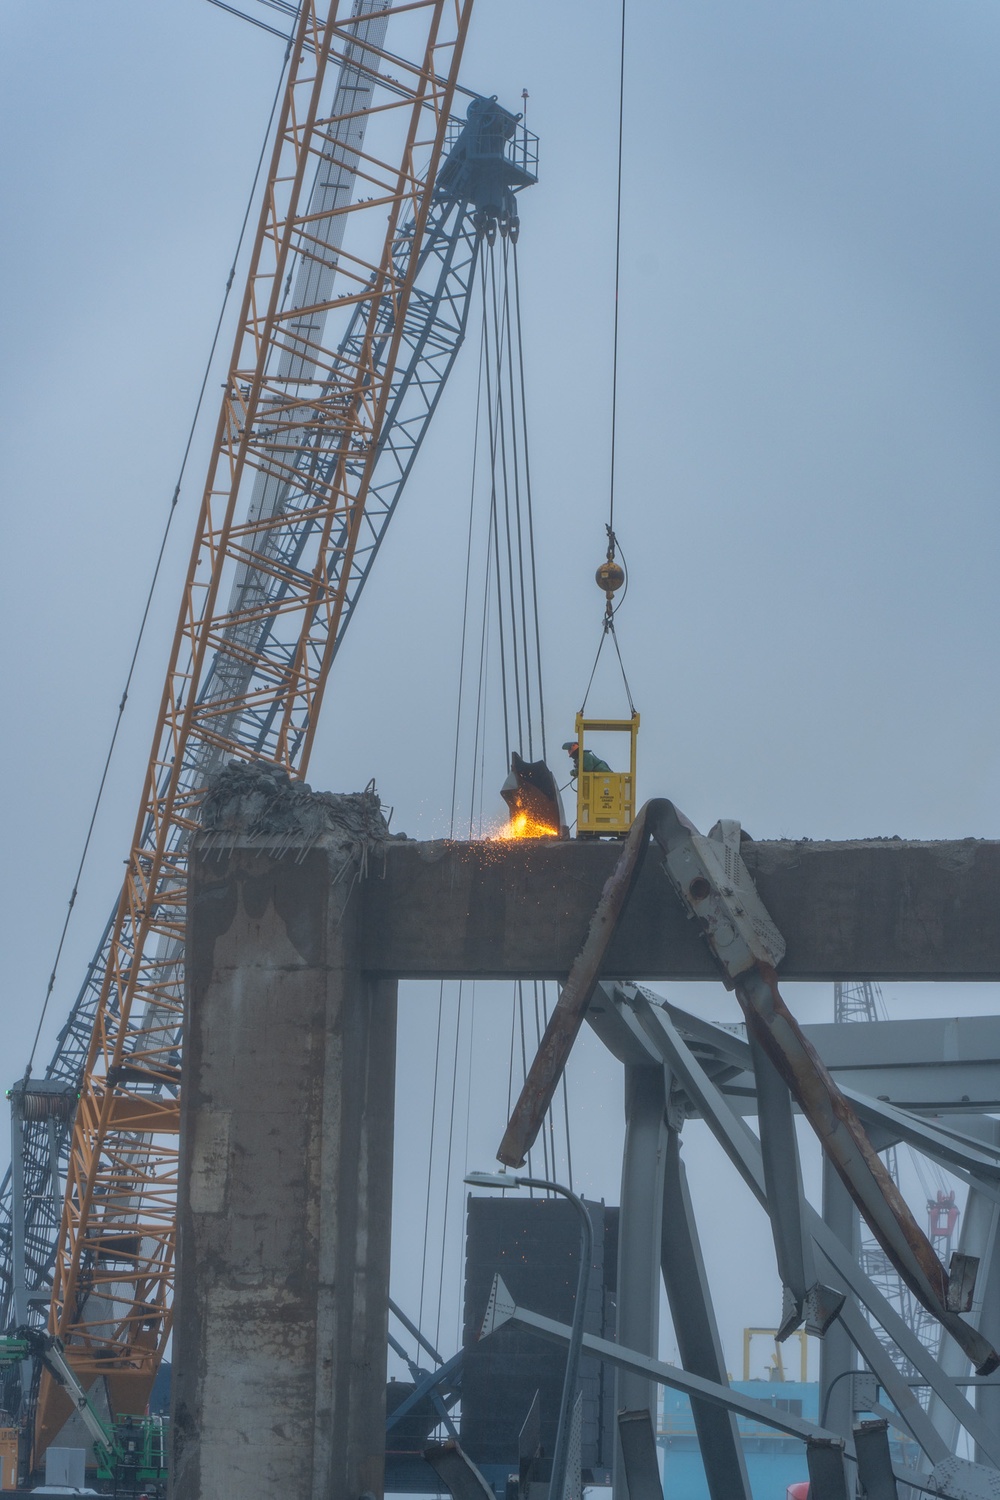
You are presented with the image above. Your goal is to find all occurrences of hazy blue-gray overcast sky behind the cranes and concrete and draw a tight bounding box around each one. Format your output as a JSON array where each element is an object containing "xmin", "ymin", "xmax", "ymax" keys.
[{"xmin": 0, "ymin": 0, "xmax": 1000, "ymax": 1410}]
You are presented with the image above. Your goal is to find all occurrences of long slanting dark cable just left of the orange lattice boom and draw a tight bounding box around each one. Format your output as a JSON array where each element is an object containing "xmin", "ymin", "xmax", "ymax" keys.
[{"xmin": 24, "ymin": 29, "xmax": 292, "ymax": 1079}]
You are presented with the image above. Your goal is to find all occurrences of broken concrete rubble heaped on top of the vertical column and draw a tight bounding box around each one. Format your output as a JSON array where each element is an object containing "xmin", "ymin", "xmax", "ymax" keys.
[{"xmin": 201, "ymin": 761, "xmax": 406, "ymax": 876}]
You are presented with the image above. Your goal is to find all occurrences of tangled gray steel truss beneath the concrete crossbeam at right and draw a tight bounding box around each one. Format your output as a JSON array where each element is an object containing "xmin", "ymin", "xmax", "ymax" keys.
[{"xmin": 588, "ymin": 983, "xmax": 1000, "ymax": 1500}]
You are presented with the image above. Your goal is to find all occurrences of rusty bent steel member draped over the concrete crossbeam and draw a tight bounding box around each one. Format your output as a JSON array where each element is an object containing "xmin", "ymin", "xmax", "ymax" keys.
[{"xmin": 498, "ymin": 798, "xmax": 1000, "ymax": 1374}]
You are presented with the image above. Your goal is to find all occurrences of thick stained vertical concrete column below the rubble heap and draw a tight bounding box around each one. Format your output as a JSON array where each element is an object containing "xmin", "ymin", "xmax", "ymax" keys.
[{"xmin": 172, "ymin": 834, "xmax": 396, "ymax": 1500}]
